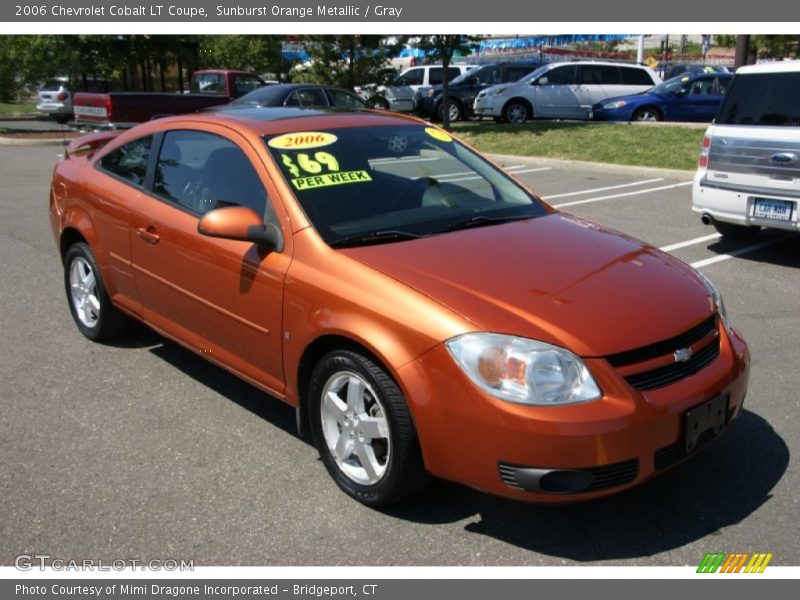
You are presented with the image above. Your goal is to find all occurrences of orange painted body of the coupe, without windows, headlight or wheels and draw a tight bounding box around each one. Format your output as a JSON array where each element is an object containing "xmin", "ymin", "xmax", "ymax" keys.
[{"xmin": 50, "ymin": 112, "xmax": 749, "ymax": 502}]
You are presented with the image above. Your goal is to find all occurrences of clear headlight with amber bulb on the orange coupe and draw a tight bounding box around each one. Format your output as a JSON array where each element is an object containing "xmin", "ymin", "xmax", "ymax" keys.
[{"xmin": 445, "ymin": 333, "xmax": 603, "ymax": 406}]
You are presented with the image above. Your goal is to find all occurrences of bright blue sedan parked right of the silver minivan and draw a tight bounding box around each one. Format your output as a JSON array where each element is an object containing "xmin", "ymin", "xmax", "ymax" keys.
[{"xmin": 592, "ymin": 73, "xmax": 733, "ymax": 122}]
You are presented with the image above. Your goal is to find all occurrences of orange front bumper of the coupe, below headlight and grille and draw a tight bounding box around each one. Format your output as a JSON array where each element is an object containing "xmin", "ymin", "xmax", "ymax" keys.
[{"xmin": 398, "ymin": 318, "xmax": 750, "ymax": 502}]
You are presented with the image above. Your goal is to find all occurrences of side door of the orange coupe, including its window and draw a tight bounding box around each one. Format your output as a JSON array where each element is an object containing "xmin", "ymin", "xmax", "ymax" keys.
[{"xmin": 131, "ymin": 126, "xmax": 291, "ymax": 393}]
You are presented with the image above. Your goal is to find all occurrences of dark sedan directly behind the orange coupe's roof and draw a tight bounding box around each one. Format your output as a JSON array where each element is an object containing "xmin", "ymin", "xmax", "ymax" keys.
[{"xmin": 222, "ymin": 83, "xmax": 367, "ymax": 110}]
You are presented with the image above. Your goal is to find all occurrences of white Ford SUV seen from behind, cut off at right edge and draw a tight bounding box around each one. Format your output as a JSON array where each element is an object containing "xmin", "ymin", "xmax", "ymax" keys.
[{"xmin": 692, "ymin": 61, "xmax": 800, "ymax": 238}]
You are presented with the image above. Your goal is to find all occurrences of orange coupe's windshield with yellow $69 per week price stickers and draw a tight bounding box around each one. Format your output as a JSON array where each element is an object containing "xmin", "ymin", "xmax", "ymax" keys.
[{"xmin": 266, "ymin": 125, "xmax": 549, "ymax": 246}]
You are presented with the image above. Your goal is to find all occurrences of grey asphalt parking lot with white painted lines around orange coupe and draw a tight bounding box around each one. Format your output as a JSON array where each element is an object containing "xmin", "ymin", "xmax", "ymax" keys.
[{"xmin": 0, "ymin": 146, "xmax": 800, "ymax": 566}]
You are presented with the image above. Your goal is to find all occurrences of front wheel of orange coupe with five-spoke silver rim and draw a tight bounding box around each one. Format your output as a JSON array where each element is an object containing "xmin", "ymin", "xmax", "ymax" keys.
[{"xmin": 308, "ymin": 350, "xmax": 427, "ymax": 507}]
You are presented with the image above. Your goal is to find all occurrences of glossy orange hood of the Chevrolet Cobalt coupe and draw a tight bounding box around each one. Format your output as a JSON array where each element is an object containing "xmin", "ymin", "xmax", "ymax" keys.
[{"xmin": 341, "ymin": 213, "xmax": 713, "ymax": 357}]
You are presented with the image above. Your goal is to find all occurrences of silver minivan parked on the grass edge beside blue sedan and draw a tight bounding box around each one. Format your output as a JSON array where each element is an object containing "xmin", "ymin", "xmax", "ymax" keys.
[{"xmin": 475, "ymin": 61, "xmax": 661, "ymax": 123}]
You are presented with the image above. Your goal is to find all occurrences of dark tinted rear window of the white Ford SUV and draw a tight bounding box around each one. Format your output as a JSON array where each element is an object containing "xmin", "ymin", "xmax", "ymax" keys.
[{"xmin": 716, "ymin": 72, "xmax": 800, "ymax": 127}]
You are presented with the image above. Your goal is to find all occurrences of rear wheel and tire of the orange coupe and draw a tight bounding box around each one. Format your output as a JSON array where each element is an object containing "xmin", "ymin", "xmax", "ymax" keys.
[{"xmin": 64, "ymin": 242, "xmax": 127, "ymax": 342}]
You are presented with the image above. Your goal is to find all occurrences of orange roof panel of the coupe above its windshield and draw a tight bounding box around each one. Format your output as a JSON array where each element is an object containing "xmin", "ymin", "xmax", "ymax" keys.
[{"xmin": 159, "ymin": 107, "xmax": 426, "ymax": 135}]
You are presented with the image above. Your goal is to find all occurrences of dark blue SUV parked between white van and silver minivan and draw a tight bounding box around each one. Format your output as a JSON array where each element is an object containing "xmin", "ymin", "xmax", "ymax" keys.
[{"xmin": 414, "ymin": 61, "xmax": 542, "ymax": 122}]
